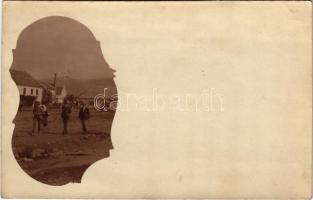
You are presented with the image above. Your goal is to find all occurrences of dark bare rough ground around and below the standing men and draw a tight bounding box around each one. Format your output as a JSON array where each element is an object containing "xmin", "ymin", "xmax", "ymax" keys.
[{"xmin": 12, "ymin": 109, "xmax": 114, "ymax": 185}]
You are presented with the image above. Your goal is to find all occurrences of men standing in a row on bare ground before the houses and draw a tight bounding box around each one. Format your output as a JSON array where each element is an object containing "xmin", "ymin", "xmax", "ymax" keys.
[{"xmin": 31, "ymin": 100, "xmax": 90, "ymax": 135}]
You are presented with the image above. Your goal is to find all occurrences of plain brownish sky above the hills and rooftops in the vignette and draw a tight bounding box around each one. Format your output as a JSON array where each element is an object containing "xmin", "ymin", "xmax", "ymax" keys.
[{"xmin": 12, "ymin": 16, "xmax": 113, "ymax": 79}]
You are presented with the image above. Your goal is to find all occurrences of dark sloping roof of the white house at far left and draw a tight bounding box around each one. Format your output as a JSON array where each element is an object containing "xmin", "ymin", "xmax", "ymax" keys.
[{"xmin": 10, "ymin": 69, "xmax": 42, "ymax": 88}]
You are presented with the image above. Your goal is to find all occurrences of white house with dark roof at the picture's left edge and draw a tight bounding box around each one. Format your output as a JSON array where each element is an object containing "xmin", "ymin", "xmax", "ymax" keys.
[{"xmin": 10, "ymin": 69, "xmax": 43, "ymax": 105}]
